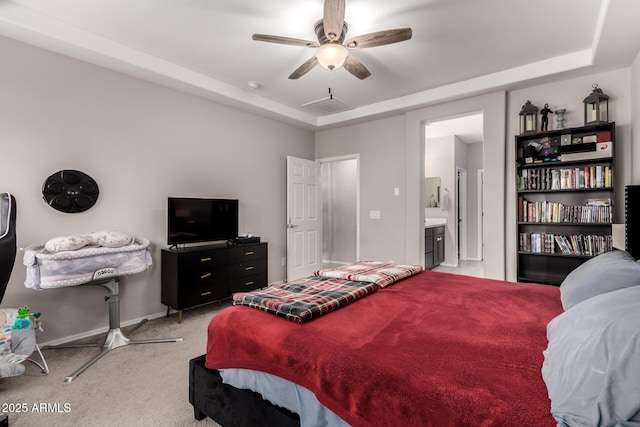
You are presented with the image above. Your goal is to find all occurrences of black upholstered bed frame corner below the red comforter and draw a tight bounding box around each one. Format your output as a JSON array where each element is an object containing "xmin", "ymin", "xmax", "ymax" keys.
[{"xmin": 189, "ymin": 354, "xmax": 300, "ymax": 427}]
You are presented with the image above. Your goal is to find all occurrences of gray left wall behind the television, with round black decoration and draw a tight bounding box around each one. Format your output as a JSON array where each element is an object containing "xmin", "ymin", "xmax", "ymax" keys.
[{"xmin": 0, "ymin": 38, "xmax": 314, "ymax": 342}]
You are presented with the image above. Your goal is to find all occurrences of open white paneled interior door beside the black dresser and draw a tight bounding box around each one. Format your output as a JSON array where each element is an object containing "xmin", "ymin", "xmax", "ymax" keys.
[{"xmin": 287, "ymin": 156, "xmax": 322, "ymax": 281}]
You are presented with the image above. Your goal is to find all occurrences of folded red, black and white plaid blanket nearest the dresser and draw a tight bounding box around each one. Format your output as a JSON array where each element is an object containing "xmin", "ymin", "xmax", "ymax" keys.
[{"xmin": 233, "ymin": 276, "xmax": 376, "ymax": 323}]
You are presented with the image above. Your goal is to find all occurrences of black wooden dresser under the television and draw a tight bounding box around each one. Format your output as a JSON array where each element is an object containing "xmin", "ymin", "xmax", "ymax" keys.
[{"xmin": 161, "ymin": 242, "xmax": 267, "ymax": 322}]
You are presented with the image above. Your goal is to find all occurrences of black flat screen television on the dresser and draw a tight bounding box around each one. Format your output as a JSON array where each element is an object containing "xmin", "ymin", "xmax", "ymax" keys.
[{"xmin": 167, "ymin": 197, "xmax": 238, "ymax": 245}]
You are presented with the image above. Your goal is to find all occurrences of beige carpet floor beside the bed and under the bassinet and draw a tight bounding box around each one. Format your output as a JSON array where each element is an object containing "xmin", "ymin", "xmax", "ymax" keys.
[{"xmin": 0, "ymin": 303, "xmax": 229, "ymax": 427}]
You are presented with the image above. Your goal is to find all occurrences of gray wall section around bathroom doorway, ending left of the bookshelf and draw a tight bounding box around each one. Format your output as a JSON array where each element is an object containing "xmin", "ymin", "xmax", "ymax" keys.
[{"xmin": 316, "ymin": 92, "xmax": 506, "ymax": 278}]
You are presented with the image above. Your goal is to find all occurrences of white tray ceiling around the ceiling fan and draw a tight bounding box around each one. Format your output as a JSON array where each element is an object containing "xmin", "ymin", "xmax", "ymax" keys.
[{"xmin": 0, "ymin": 0, "xmax": 640, "ymax": 129}]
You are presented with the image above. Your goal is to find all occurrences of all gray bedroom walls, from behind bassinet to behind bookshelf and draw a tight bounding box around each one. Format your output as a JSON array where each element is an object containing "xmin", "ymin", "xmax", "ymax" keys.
[{"xmin": 0, "ymin": 33, "xmax": 640, "ymax": 342}]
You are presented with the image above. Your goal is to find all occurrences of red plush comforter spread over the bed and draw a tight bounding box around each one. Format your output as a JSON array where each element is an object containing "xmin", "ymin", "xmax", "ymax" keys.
[{"xmin": 206, "ymin": 271, "xmax": 562, "ymax": 426}]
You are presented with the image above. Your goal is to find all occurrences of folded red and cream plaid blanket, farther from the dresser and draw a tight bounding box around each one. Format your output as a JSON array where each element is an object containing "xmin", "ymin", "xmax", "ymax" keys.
[{"xmin": 314, "ymin": 261, "xmax": 422, "ymax": 288}]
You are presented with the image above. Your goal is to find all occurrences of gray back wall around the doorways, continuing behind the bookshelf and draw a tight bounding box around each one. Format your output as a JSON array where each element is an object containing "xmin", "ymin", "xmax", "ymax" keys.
[{"xmin": 316, "ymin": 67, "xmax": 640, "ymax": 281}]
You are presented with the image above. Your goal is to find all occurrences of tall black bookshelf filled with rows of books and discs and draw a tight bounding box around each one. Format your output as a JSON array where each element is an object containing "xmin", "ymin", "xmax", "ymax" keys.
[{"xmin": 515, "ymin": 123, "xmax": 615, "ymax": 285}]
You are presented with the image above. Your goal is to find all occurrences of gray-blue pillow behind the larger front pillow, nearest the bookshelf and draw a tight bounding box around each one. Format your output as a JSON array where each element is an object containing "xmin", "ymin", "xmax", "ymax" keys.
[{"xmin": 560, "ymin": 249, "xmax": 640, "ymax": 311}]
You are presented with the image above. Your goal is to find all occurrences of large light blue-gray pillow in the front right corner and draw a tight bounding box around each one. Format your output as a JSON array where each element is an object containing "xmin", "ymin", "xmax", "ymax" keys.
[{"xmin": 542, "ymin": 286, "xmax": 640, "ymax": 427}]
